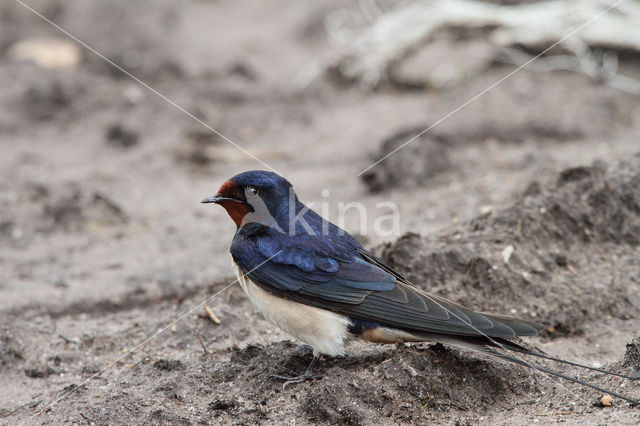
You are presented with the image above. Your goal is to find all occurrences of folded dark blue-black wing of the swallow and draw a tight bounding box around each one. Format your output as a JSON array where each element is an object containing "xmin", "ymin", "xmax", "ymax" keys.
[{"xmin": 234, "ymin": 241, "xmax": 542, "ymax": 338}]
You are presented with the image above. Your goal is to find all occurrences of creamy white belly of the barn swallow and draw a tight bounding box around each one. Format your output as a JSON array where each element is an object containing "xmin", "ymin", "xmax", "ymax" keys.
[{"xmin": 233, "ymin": 262, "xmax": 349, "ymax": 356}]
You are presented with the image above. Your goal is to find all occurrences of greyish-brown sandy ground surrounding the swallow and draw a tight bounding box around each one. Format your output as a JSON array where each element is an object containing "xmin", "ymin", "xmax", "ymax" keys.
[{"xmin": 0, "ymin": 0, "xmax": 640, "ymax": 424}]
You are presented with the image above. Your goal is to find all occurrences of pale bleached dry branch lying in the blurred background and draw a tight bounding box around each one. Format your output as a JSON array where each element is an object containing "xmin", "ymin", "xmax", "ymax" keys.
[{"xmin": 327, "ymin": 0, "xmax": 640, "ymax": 86}]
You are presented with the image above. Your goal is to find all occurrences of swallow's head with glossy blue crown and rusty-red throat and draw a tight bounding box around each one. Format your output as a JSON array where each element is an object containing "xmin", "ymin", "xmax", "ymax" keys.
[{"xmin": 202, "ymin": 170, "xmax": 297, "ymax": 227}]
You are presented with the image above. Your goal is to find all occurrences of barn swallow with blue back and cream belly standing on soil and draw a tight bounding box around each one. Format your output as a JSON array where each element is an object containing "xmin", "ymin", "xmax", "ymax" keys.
[{"xmin": 202, "ymin": 171, "xmax": 640, "ymax": 404}]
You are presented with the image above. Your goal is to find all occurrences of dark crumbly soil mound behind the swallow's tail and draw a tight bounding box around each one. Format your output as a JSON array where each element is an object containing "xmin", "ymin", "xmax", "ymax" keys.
[{"xmin": 378, "ymin": 155, "xmax": 640, "ymax": 335}]
